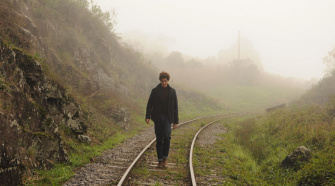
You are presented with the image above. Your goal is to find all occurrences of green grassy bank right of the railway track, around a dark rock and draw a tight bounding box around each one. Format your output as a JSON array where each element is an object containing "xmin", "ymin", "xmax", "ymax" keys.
[{"xmin": 194, "ymin": 102, "xmax": 335, "ymax": 185}]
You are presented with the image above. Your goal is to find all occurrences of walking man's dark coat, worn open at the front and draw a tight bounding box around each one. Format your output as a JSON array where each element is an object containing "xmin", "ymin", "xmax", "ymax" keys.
[{"xmin": 145, "ymin": 84, "xmax": 179, "ymax": 124}]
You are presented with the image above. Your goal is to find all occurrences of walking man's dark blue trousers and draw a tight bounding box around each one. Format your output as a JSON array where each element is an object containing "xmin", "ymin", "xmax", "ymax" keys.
[{"xmin": 155, "ymin": 115, "xmax": 171, "ymax": 161}]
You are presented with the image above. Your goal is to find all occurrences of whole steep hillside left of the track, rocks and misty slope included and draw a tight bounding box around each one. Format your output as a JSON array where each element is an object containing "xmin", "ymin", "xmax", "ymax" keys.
[{"xmin": 0, "ymin": 0, "xmax": 222, "ymax": 185}]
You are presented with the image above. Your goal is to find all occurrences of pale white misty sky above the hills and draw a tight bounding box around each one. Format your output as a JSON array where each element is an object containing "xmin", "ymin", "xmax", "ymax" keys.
[{"xmin": 97, "ymin": 0, "xmax": 335, "ymax": 80}]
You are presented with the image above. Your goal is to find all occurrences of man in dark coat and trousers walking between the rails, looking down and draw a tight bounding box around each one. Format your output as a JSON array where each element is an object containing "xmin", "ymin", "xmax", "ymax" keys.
[{"xmin": 145, "ymin": 72, "xmax": 179, "ymax": 168}]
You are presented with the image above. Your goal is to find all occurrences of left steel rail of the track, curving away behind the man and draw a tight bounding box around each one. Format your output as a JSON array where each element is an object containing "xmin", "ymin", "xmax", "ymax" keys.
[{"xmin": 117, "ymin": 113, "xmax": 232, "ymax": 186}]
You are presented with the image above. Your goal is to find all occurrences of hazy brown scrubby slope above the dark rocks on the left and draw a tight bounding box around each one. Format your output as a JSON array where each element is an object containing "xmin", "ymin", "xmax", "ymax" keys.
[{"xmin": 0, "ymin": 0, "xmax": 150, "ymax": 128}]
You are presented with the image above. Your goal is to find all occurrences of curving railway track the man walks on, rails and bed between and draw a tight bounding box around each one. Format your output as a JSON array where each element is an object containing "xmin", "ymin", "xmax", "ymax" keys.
[{"xmin": 118, "ymin": 113, "xmax": 246, "ymax": 185}]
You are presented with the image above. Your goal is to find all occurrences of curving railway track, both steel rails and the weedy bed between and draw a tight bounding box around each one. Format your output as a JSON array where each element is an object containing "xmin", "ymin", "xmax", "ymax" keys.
[{"xmin": 118, "ymin": 113, "xmax": 250, "ymax": 186}]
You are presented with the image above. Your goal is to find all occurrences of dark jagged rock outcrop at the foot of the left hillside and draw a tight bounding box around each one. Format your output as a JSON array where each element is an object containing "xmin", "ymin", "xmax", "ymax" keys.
[{"xmin": 0, "ymin": 37, "xmax": 86, "ymax": 185}]
